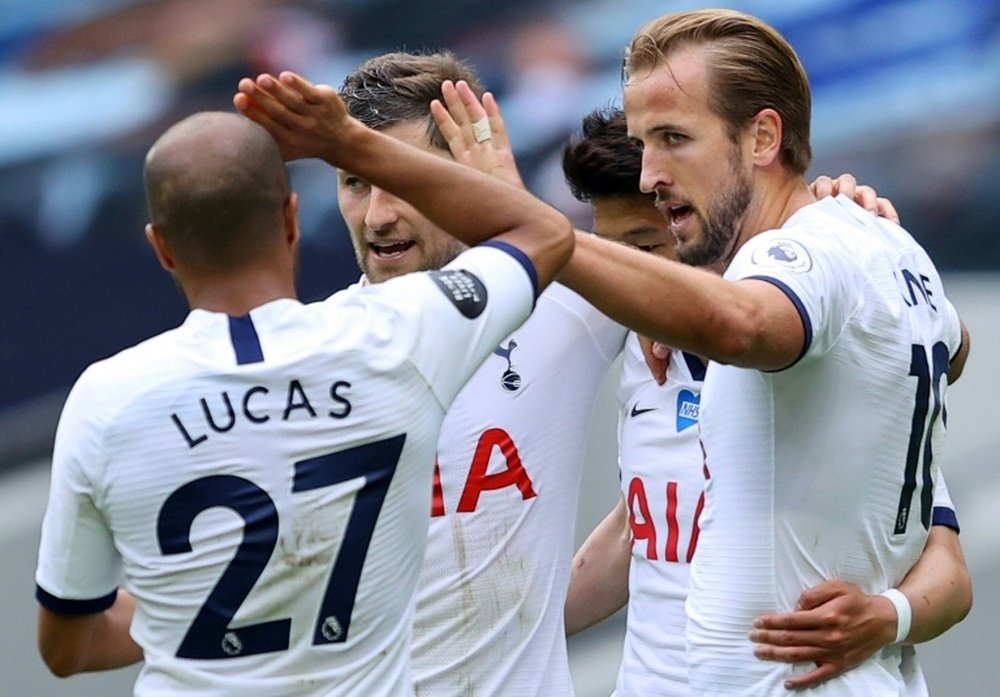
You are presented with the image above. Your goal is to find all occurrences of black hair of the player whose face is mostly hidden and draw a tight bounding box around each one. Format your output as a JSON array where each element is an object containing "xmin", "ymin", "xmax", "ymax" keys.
[{"xmin": 563, "ymin": 107, "xmax": 642, "ymax": 202}]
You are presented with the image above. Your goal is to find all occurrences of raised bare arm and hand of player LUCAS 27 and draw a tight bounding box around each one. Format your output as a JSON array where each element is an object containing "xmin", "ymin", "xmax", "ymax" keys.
[{"xmin": 233, "ymin": 72, "xmax": 573, "ymax": 289}]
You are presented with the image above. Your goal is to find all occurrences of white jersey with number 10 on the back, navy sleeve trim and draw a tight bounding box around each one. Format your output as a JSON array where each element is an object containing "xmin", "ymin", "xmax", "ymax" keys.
[{"xmin": 687, "ymin": 196, "xmax": 961, "ymax": 697}]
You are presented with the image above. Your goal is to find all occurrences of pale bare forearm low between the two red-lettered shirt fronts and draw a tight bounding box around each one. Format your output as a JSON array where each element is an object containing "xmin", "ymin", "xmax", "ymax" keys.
[{"xmin": 566, "ymin": 498, "xmax": 632, "ymax": 636}]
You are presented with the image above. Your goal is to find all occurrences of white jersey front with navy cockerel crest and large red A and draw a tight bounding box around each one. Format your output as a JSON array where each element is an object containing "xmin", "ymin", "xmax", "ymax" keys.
[{"xmin": 412, "ymin": 284, "xmax": 625, "ymax": 697}]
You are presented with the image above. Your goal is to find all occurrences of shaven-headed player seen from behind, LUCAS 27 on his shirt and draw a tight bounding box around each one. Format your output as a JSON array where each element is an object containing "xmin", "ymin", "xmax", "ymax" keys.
[{"xmin": 36, "ymin": 100, "xmax": 573, "ymax": 695}]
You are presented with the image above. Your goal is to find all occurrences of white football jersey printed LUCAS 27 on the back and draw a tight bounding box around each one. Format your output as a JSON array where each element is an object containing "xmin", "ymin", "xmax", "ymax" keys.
[{"xmin": 36, "ymin": 244, "xmax": 534, "ymax": 697}]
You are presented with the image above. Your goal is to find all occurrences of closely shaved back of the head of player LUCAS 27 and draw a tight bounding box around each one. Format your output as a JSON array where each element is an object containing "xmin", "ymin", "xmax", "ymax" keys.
[{"xmin": 143, "ymin": 112, "xmax": 291, "ymax": 268}]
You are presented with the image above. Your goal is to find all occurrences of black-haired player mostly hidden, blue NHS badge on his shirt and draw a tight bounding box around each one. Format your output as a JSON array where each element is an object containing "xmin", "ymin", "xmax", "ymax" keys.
[{"xmin": 563, "ymin": 109, "xmax": 971, "ymax": 696}]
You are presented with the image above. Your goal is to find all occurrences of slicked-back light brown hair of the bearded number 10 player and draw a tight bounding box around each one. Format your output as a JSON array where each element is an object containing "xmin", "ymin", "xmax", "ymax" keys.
[{"xmin": 625, "ymin": 10, "xmax": 812, "ymax": 174}]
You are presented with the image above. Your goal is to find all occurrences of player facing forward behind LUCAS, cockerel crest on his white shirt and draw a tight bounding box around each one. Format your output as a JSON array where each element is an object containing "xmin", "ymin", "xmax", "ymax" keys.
[{"xmin": 234, "ymin": 53, "xmax": 625, "ymax": 697}]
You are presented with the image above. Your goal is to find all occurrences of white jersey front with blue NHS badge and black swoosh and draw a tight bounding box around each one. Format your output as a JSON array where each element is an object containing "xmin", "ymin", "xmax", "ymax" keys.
[{"xmin": 615, "ymin": 334, "xmax": 705, "ymax": 697}]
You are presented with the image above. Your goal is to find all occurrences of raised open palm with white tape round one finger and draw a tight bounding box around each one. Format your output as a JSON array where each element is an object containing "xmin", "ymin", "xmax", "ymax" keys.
[{"xmin": 431, "ymin": 80, "xmax": 525, "ymax": 189}]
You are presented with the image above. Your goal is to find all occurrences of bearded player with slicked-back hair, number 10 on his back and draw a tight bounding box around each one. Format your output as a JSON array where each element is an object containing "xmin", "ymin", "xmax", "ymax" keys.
[{"xmin": 560, "ymin": 10, "xmax": 968, "ymax": 695}]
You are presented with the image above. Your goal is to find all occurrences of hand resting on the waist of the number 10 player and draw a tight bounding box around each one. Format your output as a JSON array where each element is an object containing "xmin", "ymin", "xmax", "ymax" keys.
[{"xmin": 749, "ymin": 581, "xmax": 896, "ymax": 690}]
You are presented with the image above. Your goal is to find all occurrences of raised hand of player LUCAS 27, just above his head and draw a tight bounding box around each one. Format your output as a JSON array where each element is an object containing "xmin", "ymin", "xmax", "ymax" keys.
[{"xmin": 233, "ymin": 71, "xmax": 352, "ymax": 161}]
